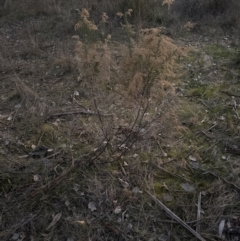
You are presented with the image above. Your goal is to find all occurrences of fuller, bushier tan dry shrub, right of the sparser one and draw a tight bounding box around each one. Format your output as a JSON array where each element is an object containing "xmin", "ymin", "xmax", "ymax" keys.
[{"xmin": 121, "ymin": 28, "xmax": 184, "ymax": 97}]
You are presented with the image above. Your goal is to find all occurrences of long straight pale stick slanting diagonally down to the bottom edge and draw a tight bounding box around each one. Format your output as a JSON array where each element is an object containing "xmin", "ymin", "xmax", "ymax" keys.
[{"xmin": 147, "ymin": 191, "xmax": 206, "ymax": 241}]
